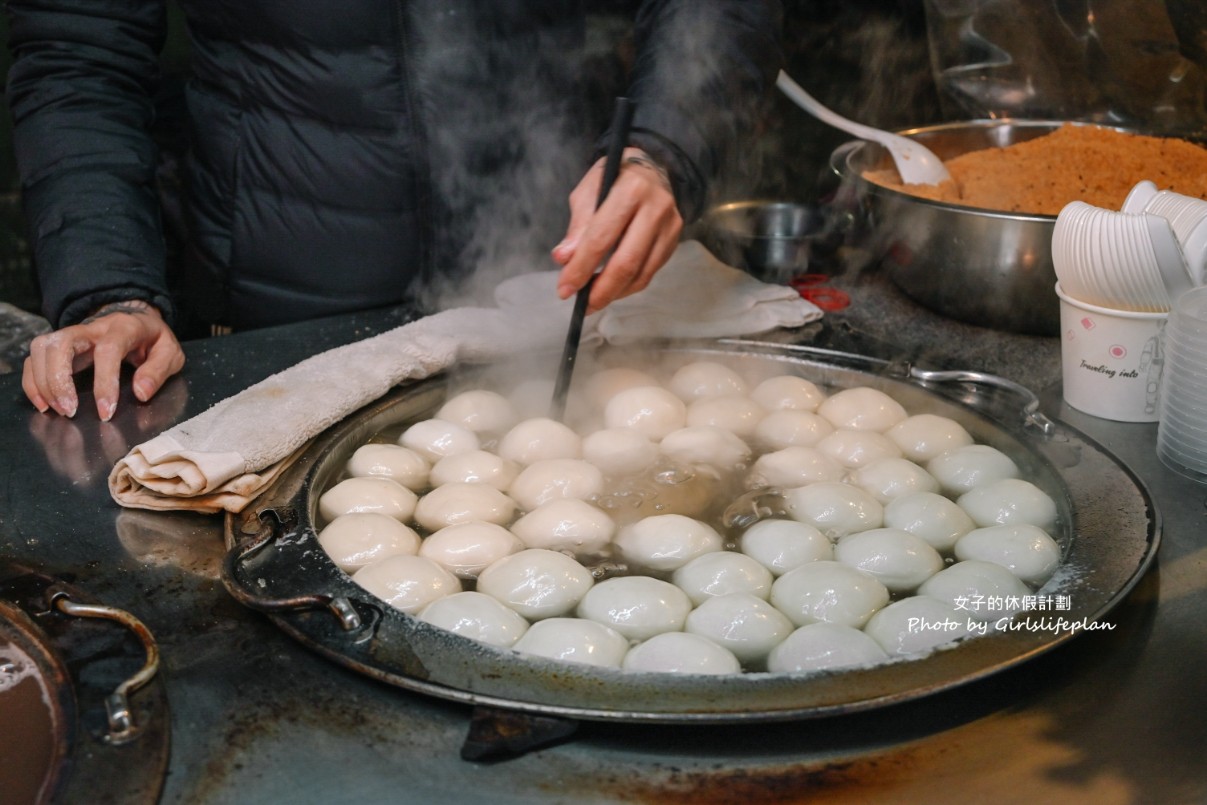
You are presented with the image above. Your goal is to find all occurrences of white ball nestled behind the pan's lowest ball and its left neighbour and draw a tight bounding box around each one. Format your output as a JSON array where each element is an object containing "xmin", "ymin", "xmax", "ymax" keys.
[{"xmin": 578, "ymin": 576, "xmax": 692, "ymax": 641}]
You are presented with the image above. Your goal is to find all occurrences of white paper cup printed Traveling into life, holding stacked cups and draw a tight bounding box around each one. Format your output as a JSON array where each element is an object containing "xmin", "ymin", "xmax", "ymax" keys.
[{"xmin": 1056, "ymin": 282, "xmax": 1168, "ymax": 422}]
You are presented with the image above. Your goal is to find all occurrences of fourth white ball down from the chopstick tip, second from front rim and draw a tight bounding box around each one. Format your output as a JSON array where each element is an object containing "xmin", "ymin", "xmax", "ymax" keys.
[{"xmin": 478, "ymin": 548, "xmax": 595, "ymax": 620}]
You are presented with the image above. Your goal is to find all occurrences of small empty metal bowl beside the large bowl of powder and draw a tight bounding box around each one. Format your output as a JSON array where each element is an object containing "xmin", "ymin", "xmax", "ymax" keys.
[{"xmin": 701, "ymin": 200, "xmax": 827, "ymax": 282}]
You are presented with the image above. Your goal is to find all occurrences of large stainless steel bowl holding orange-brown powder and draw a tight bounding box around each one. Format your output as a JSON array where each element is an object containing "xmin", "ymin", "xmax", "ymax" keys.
[{"xmin": 830, "ymin": 119, "xmax": 1063, "ymax": 336}]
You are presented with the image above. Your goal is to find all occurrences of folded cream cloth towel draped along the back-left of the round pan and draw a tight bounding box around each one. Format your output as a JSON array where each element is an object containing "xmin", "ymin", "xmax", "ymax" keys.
[{"xmin": 109, "ymin": 241, "xmax": 822, "ymax": 512}]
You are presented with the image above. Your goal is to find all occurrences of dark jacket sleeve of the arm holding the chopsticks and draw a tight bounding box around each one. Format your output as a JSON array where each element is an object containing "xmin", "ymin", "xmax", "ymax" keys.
[{"xmin": 613, "ymin": 0, "xmax": 783, "ymax": 222}]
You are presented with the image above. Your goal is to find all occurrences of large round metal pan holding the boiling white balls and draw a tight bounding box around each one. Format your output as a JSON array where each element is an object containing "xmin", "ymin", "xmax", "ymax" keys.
[{"xmin": 225, "ymin": 342, "xmax": 1160, "ymax": 723}]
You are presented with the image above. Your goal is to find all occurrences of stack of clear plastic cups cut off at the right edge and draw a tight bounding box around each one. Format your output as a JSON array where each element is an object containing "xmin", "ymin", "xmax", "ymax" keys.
[{"xmin": 1156, "ymin": 286, "xmax": 1207, "ymax": 482}]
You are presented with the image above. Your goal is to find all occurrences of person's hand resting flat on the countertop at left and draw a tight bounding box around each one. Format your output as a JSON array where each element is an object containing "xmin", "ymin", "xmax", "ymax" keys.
[{"xmin": 21, "ymin": 299, "xmax": 185, "ymax": 421}]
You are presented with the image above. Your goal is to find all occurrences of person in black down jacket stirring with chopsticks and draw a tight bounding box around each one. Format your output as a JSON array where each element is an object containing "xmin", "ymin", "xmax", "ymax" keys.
[{"xmin": 7, "ymin": 0, "xmax": 782, "ymax": 420}]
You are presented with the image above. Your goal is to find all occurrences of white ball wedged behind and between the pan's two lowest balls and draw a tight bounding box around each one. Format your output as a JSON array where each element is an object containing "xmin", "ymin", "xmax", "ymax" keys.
[{"xmin": 684, "ymin": 593, "xmax": 793, "ymax": 669}]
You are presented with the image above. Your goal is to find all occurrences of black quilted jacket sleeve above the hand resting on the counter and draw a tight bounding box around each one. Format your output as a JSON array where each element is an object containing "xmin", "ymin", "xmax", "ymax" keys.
[{"xmin": 7, "ymin": 0, "xmax": 171, "ymax": 326}]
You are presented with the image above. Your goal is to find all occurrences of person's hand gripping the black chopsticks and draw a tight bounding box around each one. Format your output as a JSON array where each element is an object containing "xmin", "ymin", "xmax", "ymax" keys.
[{"xmin": 553, "ymin": 147, "xmax": 683, "ymax": 313}]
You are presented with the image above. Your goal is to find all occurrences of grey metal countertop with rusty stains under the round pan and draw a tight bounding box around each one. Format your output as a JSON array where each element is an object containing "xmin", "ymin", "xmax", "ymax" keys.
[{"xmin": 0, "ymin": 272, "xmax": 1207, "ymax": 804}]
